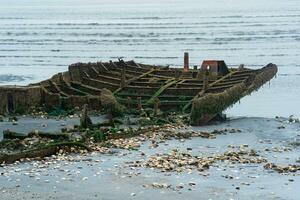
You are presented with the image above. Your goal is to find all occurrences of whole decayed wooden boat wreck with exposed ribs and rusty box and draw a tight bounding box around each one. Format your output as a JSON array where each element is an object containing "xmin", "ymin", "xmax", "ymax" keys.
[{"xmin": 0, "ymin": 53, "xmax": 277, "ymax": 125}]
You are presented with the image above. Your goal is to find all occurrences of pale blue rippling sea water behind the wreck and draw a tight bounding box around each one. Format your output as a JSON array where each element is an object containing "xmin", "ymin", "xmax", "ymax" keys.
[{"xmin": 0, "ymin": 0, "xmax": 300, "ymax": 117}]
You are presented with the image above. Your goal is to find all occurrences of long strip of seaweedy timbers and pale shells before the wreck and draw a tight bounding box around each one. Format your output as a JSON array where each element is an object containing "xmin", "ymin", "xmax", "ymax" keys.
[{"xmin": 0, "ymin": 117, "xmax": 227, "ymax": 166}]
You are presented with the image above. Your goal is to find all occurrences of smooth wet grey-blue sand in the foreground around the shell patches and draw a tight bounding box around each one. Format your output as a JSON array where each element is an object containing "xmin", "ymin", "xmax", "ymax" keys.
[{"xmin": 0, "ymin": 118, "xmax": 300, "ymax": 200}]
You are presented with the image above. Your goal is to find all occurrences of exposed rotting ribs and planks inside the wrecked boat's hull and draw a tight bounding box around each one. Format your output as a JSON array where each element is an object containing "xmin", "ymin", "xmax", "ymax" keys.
[{"xmin": 0, "ymin": 60, "xmax": 277, "ymax": 126}]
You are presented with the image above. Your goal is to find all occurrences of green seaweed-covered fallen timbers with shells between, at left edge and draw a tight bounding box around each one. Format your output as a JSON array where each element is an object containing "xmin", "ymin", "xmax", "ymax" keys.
[{"xmin": 0, "ymin": 130, "xmax": 90, "ymax": 163}]
